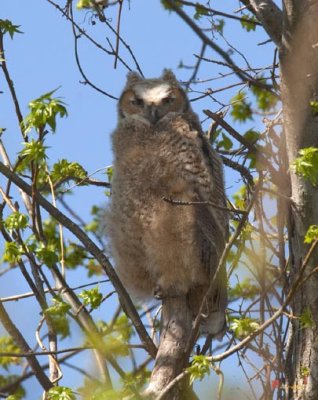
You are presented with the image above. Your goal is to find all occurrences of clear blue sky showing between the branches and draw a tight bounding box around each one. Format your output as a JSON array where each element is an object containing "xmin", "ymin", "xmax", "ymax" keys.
[{"xmin": 0, "ymin": 0, "xmax": 272, "ymax": 400}]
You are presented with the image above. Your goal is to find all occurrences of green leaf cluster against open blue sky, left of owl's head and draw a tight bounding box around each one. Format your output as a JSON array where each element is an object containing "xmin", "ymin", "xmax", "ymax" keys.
[{"xmin": 22, "ymin": 89, "xmax": 67, "ymax": 133}]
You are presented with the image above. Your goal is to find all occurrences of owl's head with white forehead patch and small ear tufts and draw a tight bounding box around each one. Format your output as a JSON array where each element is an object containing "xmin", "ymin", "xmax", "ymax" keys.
[{"xmin": 118, "ymin": 70, "xmax": 190, "ymax": 125}]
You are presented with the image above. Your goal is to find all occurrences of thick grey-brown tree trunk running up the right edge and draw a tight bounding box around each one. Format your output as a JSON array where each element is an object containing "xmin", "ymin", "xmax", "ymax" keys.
[{"xmin": 280, "ymin": 0, "xmax": 318, "ymax": 400}]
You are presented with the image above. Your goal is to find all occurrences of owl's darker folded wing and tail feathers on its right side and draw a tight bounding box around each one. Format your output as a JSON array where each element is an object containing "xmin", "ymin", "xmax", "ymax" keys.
[{"xmin": 189, "ymin": 118, "xmax": 229, "ymax": 339}]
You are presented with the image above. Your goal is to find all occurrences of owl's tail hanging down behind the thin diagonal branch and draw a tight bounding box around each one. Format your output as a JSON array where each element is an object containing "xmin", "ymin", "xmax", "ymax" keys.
[{"xmin": 188, "ymin": 274, "xmax": 227, "ymax": 340}]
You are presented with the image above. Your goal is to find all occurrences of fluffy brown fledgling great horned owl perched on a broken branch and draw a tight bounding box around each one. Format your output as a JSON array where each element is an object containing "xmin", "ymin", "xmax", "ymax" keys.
[{"xmin": 108, "ymin": 70, "xmax": 228, "ymax": 336}]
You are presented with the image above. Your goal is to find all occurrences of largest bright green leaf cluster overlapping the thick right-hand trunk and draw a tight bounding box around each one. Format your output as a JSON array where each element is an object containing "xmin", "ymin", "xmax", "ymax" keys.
[{"xmin": 291, "ymin": 147, "xmax": 318, "ymax": 186}]
